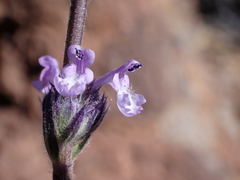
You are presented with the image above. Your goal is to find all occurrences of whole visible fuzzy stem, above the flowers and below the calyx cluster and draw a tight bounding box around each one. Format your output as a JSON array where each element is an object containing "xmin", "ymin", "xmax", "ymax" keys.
[{"xmin": 53, "ymin": 0, "xmax": 90, "ymax": 180}]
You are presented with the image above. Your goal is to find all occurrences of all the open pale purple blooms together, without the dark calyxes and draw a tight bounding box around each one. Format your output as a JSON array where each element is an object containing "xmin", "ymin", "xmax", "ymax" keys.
[{"xmin": 33, "ymin": 45, "xmax": 146, "ymax": 117}]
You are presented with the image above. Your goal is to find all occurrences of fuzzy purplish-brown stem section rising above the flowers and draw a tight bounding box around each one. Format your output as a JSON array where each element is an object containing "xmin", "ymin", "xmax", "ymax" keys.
[{"xmin": 63, "ymin": 0, "xmax": 90, "ymax": 66}]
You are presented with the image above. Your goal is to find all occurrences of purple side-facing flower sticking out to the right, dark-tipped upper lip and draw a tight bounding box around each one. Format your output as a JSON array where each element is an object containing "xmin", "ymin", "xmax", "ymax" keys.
[{"xmin": 93, "ymin": 59, "xmax": 146, "ymax": 117}]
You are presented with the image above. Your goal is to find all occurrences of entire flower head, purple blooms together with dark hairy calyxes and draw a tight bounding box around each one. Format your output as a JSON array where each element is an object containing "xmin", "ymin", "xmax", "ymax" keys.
[{"xmin": 33, "ymin": 45, "xmax": 146, "ymax": 174}]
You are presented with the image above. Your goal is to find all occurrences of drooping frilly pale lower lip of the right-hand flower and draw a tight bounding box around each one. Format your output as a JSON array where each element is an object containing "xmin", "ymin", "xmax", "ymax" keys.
[{"xmin": 117, "ymin": 93, "xmax": 146, "ymax": 117}]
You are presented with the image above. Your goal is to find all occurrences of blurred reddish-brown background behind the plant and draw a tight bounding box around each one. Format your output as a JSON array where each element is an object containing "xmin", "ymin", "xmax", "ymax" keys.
[{"xmin": 0, "ymin": 0, "xmax": 240, "ymax": 180}]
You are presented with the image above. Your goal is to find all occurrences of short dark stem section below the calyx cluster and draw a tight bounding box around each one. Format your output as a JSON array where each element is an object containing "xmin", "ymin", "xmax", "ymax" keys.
[{"xmin": 53, "ymin": 163, "xmax": 74, "ymax": 180}]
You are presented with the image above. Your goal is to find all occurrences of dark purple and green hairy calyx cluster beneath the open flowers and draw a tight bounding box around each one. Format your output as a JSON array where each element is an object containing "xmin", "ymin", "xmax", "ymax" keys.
[{"xmin": 42, "ymin": 83, "xmax": 107, "ymax": 164}]
